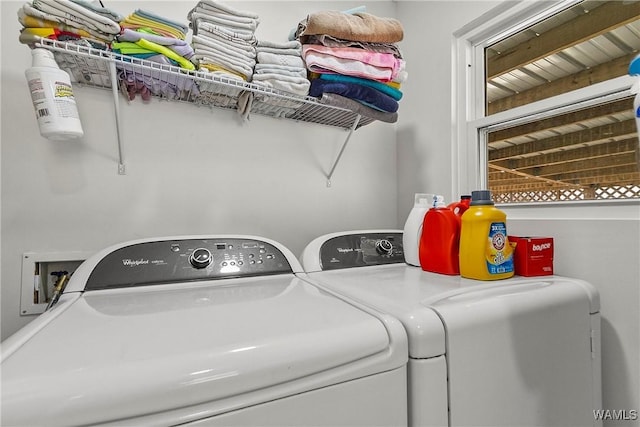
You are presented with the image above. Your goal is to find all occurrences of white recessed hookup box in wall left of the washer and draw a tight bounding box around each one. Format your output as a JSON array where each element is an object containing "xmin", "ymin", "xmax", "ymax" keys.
[{"xmin": 20, "ymin": 252, "xmax": 92, "ymax": 316}]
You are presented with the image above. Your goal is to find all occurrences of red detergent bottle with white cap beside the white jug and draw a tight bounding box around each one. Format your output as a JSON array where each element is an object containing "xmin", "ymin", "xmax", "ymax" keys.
[{"xmin": 419, "ymin": 196, "xmax": 460, "ymax": 275}]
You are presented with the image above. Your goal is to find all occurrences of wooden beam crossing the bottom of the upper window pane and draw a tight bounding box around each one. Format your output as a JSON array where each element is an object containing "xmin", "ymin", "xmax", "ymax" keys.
[{"xmin": 487, "ymin": 52, "xmax": 640, "ymax": 115}]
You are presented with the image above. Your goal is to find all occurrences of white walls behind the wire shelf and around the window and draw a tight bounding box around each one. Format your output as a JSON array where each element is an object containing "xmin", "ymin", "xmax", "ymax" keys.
[{"xmin": 0, "ymin": 0, "xmax": 640, "ymax": 426}]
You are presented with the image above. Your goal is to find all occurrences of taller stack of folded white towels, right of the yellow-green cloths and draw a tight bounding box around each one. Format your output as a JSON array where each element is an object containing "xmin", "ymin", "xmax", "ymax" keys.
[{"xmin": 187, "ymin": 0, "xmax": 260, "ymax": 81}]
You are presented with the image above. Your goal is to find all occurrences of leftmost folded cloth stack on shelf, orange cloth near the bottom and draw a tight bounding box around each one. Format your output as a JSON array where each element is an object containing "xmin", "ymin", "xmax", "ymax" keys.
[{"xmin": 18, "ymin": 0, "xmax": 122, "ymax": 49}]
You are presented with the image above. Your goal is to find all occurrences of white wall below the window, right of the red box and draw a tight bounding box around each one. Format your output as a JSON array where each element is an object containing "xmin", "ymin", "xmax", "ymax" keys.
[{"xmin": 504, "ymin": 204, "xmax": 640, "ymax": 426}]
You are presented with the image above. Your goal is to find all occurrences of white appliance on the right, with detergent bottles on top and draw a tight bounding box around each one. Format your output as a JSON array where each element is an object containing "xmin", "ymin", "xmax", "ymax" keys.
[{"xmin": 301, "ymin": 230, "xmax": 602, "ymax": 427}]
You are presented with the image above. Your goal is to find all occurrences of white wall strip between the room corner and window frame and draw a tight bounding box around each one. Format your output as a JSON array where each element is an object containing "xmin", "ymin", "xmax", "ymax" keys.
[{"xmin": 397, "ymin": 0, "xmax": 500, "ymax": 217}]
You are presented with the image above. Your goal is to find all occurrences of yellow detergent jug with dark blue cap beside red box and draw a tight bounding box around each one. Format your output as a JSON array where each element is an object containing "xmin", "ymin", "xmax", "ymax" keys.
[{"xmin": 460, "ymin": 190, "xmax": 514, "ymax": 280}]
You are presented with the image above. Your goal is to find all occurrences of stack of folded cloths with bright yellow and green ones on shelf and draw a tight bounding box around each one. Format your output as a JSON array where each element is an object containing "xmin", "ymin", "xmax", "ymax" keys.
[{"xmin": 112, "ymin": 9, "xmax": 197, "ymax": 101}]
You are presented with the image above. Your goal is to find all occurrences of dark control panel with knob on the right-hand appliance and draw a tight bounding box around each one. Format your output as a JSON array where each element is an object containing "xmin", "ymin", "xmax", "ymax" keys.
[{"xmin": 320, "ymin": 233, "xmax": 404, "ymax": 270}]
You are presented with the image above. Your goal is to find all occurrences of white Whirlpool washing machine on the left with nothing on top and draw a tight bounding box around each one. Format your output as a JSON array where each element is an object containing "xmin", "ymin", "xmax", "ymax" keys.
[{"xmin": 1, "ymin": 235, "xmax": 408, "ymax": 426}]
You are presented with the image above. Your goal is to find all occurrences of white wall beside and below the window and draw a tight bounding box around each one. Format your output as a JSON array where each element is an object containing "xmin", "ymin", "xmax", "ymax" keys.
[{"xmin": 397, "ymin": 1, "xmax": 640, "ymax": 426}]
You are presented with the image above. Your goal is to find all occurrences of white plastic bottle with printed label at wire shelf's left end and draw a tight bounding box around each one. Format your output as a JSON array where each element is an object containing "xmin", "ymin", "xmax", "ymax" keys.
[{"xmin": 25, "ymin": 48, "xmax": 84, "ymax": 141}]
